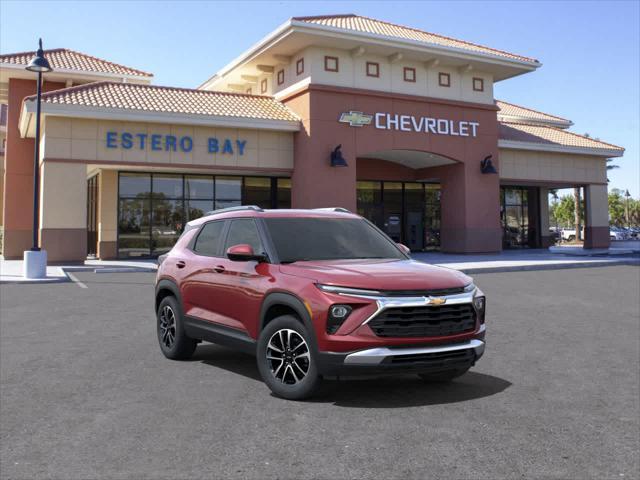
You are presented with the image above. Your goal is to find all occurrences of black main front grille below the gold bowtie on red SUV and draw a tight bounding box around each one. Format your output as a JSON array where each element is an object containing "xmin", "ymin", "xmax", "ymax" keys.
[{"xmin": 368, "ymin": 303, "xmax": 476, "ymax": 337}]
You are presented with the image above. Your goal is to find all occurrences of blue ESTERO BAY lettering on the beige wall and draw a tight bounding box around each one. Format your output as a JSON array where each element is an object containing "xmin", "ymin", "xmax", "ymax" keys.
[{"xmin": 105, "ymin": 132, "xmax": 247, "ymax": 155}]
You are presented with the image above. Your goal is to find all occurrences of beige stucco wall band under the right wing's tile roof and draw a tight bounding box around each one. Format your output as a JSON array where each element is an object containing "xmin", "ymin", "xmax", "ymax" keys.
[{"xmin": 499, "ymin": 148, "xmax": 607, "ymax": 184}]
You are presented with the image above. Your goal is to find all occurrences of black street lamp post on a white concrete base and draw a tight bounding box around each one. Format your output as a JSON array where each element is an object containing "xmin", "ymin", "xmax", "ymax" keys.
[{"xmin": 24, "ymin": 39, "xmax": 53, "ymax": 278}]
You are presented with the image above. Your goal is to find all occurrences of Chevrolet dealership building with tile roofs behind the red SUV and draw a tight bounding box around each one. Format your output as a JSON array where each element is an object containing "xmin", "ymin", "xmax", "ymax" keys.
[{"xmin": 0, "ymin": 15, "xmax": 624, "ymax": 261}]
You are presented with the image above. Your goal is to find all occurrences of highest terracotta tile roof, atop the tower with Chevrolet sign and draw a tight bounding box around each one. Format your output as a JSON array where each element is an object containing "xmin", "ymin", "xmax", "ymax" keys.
[{"xmin": 293, "ymin": 14, "xmax": 539, "ymax": 63}]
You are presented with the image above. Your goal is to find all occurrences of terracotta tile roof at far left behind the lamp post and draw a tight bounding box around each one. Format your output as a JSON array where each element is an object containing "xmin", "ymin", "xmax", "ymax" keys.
[{"xmin": 0, "ymin": 48, "xmax": 153, "ymax": 77}]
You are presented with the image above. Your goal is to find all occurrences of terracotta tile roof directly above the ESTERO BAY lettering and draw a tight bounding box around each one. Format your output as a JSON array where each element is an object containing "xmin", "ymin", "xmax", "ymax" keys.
[{"xmin": 27, "ymin": 82, "xmax": 298, "ymax": 121}]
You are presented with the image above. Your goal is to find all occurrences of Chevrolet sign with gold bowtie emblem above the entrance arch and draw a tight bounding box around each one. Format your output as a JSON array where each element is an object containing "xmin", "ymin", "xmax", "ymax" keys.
[{"xmin": 338, "ymin": 110, "xmax": 480, "ymax": 137}]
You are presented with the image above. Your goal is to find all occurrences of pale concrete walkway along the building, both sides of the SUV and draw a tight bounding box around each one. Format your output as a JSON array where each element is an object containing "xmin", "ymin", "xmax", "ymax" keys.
[{"xmin": 0, "ymin": 249, "xmax": 640, "ymax": 283}]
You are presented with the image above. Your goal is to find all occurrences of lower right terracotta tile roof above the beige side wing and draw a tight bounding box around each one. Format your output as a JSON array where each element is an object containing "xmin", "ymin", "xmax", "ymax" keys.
[{"xmin": 498, "ymin": 122, "xmax": 624, "ymax": 154}]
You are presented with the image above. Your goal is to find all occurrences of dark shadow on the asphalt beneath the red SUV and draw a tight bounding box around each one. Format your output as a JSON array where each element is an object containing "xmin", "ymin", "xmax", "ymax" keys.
[{"xmin": 191, "ymin": 344, "xmax": 512, "ymax": 408}]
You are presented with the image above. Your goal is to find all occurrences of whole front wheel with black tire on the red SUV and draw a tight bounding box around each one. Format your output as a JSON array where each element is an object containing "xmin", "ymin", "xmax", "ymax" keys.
[{"xmin": 257, "ymin": 315, "xmax": 322, "ymax": 400}]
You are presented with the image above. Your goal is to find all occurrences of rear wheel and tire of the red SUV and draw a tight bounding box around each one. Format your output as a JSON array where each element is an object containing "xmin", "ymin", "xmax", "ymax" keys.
[{"xmin": 157, "ymin": 297, "xmax": 197, "ymax": 360}]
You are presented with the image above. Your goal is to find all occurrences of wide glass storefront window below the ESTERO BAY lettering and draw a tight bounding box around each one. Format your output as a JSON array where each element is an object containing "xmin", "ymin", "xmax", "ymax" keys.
[{"xmin": 118, "ymin": 172, "xmax": 291, "ymax": 258}]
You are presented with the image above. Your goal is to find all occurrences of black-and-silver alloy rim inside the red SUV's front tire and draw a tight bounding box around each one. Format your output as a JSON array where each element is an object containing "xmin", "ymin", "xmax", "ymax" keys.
[{"xmin": 267, "ymin": 328, "xmax": 311, "ymax": 385}]
